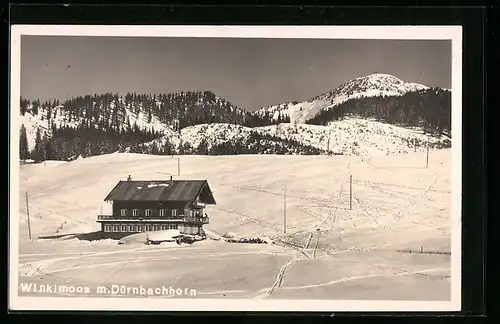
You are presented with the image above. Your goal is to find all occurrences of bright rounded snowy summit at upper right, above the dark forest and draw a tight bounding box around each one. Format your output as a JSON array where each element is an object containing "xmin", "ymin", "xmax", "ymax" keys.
[{"xmin": 253, "ymin": 73, "xmax": 429, "ymax": 123}]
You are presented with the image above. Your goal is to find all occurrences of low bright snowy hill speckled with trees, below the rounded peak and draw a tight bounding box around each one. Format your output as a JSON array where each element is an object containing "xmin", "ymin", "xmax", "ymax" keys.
[{"xmin": 131, "ymin": 118, "xmax": 451, "ymax": 156}]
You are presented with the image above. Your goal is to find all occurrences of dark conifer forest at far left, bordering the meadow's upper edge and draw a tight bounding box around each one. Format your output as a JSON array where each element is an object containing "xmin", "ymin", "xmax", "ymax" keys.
[{"xmin": 19, "ymin": 125, "xmax": 160, "ymax": 162}]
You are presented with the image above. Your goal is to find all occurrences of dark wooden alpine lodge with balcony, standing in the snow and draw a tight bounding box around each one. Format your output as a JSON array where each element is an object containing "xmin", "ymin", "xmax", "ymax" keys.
[{"xmin": 97, "ymin": 178, "xmax": 216, "ymax": 238}]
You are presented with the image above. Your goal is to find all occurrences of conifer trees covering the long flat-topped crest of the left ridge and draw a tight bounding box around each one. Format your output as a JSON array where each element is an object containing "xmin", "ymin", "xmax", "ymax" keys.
[{"xmin": 20, "ymin": 91, "xmax": 289, "ymax": 134}]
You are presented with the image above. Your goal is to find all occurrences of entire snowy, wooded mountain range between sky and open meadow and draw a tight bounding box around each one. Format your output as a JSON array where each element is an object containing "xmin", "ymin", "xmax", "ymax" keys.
[{"xmin": 20, "ymin": 73, "xmax": 451, "ymax": 160}]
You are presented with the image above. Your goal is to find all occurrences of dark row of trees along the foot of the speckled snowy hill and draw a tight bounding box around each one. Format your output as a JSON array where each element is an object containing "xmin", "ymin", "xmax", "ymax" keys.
[{"xmin": 130, "ymin": 132, "xmax": 331, "ymax": 155}]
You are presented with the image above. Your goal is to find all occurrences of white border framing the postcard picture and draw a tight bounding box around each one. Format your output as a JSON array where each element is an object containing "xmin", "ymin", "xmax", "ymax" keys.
[{"xmin": 9, "ymin": 25, "xmax": 462, "ymax": 312}]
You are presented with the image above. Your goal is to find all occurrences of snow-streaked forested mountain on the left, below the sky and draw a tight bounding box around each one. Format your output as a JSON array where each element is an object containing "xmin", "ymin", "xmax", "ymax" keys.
[{"xmin": 18, "ymin": 91, "xmax": 249, "ymax": 150}]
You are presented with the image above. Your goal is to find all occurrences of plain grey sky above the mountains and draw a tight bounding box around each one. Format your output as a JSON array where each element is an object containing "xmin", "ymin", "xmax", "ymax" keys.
[{"xmin": 21, "ymin": 36, "xmax": 451, "ymax": 111}]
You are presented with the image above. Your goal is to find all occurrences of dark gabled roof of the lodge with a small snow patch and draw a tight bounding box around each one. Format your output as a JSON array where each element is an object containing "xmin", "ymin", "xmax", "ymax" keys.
[{"xmin": 104, "ymin": 180, "xmax": 216, "ymax": 205}]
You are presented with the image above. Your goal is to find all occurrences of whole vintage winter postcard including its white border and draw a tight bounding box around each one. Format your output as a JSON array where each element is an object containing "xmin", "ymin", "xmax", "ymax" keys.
[{"xmin": 9, "ymin": 25, "xmax": 462, "ymax": 311}]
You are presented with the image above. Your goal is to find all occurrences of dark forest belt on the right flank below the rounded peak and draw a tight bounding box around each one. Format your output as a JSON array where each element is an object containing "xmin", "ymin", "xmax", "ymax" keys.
[{"xmin": 307, "ymin": 88, "xmax": 451, "ymax": 134}]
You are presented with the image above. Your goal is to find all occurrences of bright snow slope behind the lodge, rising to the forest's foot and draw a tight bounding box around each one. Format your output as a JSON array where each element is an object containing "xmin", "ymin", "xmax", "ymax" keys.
[{"xmin": 18, "ymin": 149, "xmax": 451, "ymax": 249}]
